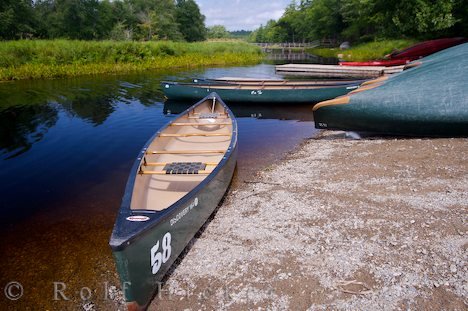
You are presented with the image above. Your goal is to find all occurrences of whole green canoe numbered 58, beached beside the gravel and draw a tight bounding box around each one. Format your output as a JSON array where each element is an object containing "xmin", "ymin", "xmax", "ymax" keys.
[{"xmin": 110, "ymin": 93, "xmax": 237, "ymax": 310}]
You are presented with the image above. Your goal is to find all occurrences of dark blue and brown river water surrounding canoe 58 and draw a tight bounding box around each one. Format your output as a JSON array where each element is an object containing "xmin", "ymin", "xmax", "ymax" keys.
[{"xmin": 0, "ymin": 65, "xmax": 315, "ymax": 309}]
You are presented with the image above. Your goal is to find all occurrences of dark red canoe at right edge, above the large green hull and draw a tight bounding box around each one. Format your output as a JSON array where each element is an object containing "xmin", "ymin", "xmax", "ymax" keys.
[{"xmin": 386, "ymin": 37, "xmax": 468, "ymax": 60}]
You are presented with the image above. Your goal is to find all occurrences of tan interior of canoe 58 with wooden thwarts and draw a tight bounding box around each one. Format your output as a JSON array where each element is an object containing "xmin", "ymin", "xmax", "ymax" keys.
[{"xmin": 130, "ymin": 99, "xmax": 233, "ymax": 211}]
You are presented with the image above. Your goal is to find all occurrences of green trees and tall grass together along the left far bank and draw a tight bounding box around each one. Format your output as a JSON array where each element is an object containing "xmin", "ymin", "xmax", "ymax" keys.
[{"xmin": 0, "ymin": 0, "xmax": 262, "ymax": 80}]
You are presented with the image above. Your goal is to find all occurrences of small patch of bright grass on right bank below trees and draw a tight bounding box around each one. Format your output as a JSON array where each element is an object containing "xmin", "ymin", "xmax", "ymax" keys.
[{"xmin": 308, "ymin": 39, "xmax": 416, "ymax": 61}]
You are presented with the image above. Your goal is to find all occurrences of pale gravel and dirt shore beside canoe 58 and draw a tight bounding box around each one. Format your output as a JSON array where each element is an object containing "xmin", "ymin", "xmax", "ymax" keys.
[{"xmin": 145, "ymin": 131, "xmax": 468, "ymax": 310}]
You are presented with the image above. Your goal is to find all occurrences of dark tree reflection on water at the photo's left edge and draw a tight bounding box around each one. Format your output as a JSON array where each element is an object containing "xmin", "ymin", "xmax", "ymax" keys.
[{"xmin": 0, "ymin": 105, "xmax": 58, "ymax": 158}]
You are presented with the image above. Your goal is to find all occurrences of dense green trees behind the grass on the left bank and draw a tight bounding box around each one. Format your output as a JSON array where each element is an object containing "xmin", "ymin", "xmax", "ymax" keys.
[{"xmin": 0, "ymin": 0, "xmax": 207, "ymax": 42}]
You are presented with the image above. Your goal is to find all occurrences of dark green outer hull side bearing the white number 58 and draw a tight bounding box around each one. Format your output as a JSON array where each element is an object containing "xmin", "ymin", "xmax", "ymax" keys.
[{"xmin": 113, "ymin": 145, "xmax": 237, "ymax": 309}]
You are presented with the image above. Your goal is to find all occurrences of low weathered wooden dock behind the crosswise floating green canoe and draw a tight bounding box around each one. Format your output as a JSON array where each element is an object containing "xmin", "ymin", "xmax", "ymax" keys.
[{"xmin": 276, "ymin": 64, "xmax": 405, "ymax": 79}]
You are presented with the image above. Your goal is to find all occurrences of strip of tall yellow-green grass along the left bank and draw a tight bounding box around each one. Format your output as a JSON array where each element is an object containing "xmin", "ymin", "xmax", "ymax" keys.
[{"xmin": 0, "ymin": 40, "xmax": 262, "ymax": 81}]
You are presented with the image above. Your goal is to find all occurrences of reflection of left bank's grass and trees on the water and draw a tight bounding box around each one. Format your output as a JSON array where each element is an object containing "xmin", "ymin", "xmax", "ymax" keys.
[{"xmin": 0, "ymin": 72, "xmax": 169, "ymax": 158}]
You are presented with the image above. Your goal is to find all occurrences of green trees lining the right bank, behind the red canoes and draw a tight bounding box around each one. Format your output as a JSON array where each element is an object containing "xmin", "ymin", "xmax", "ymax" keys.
[{"xmin": 251, "ymin": 0, "xmax": 468, "ymax": 42}]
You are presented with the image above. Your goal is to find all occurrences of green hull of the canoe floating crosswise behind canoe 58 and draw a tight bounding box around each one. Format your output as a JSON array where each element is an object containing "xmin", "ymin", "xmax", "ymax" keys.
[{"xmin": 163, "ymin": 83, "xmax": 358, "ymax": 104}]
